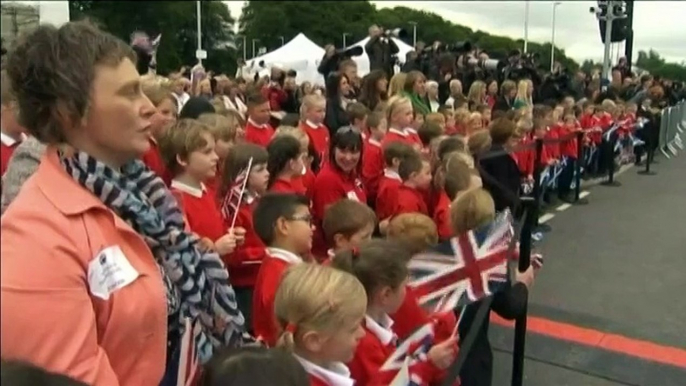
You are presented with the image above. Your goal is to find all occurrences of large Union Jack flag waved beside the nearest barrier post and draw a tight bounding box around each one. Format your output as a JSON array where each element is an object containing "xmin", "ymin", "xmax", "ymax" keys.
[{"xmin": 408, "ymin": 210, "xmax": 514, "ymax": 312}]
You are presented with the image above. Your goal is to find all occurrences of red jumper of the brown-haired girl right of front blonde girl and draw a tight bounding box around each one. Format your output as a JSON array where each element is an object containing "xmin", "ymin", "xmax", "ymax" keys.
[{"xmin": 348, "ymin": 315, "xmax": 440, "ymax": 385}]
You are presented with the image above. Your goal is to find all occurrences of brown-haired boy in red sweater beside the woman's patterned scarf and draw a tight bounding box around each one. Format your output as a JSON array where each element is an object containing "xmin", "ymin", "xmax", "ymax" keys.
[{"xmin": 160, "ymin": 119, "xmax": 245, "ymax": 261}]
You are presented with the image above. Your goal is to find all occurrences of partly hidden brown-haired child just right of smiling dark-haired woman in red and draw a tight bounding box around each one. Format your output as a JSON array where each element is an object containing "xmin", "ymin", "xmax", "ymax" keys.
[{"xmin": 374, "ymin": 141, "xmax": 417, "ymax": 221}]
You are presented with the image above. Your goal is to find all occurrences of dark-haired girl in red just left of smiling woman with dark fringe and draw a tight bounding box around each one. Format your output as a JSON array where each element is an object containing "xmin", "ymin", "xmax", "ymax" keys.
[{"xmin": 267, "ymin": 134, "xmax": 307, "ymax": 195}]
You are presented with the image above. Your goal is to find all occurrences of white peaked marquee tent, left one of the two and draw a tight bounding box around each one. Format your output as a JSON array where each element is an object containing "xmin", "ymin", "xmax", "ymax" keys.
[{"xmin": 246, "ymin": 33, "xmax": 324, "ymax": 84}]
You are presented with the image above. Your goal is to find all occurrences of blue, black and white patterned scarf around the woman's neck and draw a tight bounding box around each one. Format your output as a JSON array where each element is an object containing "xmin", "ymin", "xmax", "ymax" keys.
[{"xmin": 60, "ymin": 152, "xmax": 253, "ymax": 363}]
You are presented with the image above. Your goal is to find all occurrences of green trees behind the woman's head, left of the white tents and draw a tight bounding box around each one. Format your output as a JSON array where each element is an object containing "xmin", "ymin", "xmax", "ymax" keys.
[{"xmin": 69, "ymin": 0, "xmax": 236, "ymax": 74}]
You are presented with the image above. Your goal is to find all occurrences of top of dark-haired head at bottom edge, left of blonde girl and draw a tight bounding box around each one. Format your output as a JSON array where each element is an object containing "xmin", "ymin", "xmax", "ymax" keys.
[{"xmin": 200, "ymin": 346, "xmax": 310, "ymax": 386}]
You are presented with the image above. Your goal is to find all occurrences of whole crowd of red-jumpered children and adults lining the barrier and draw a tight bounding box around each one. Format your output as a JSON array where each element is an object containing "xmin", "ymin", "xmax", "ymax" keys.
[{"xmin": 0, "ymin": 22, "xmax": 680, "ymax": 386}]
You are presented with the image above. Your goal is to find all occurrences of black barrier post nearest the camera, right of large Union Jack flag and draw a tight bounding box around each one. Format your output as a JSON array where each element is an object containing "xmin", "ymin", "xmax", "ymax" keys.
[{"xmin": 511, "ymin": 199, "xmax": 540, "ymax": 386}]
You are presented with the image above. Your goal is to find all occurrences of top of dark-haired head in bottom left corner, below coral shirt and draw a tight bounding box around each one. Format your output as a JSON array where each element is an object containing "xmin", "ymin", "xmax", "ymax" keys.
[{"xmin": 0, "ymin": 360, "xmax": 86, "ymax": 386}]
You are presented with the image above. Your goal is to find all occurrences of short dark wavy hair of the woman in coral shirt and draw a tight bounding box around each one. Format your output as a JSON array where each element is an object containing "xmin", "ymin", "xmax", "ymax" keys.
[{"xmin": 6, "ymin": 20, "xmax": 136, "ymax": 143}]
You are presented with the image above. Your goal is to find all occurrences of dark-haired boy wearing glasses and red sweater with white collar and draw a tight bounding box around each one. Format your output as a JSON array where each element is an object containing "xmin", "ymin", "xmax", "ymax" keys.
[{"xmin": 252, "ymin": 193, "xmax": 312, "ymax": 346}]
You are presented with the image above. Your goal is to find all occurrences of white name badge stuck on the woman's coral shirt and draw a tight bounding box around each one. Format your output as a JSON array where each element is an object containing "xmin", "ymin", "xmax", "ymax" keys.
[{"xmin": 88, "ymin": 245, "xmax": 140, "ymax": 300}]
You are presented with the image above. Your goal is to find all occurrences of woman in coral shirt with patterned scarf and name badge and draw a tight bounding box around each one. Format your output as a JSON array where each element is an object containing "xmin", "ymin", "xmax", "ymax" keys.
[{"xmin": 0, "ymin": 22, "xmax": 253, "ymax": 386}]
